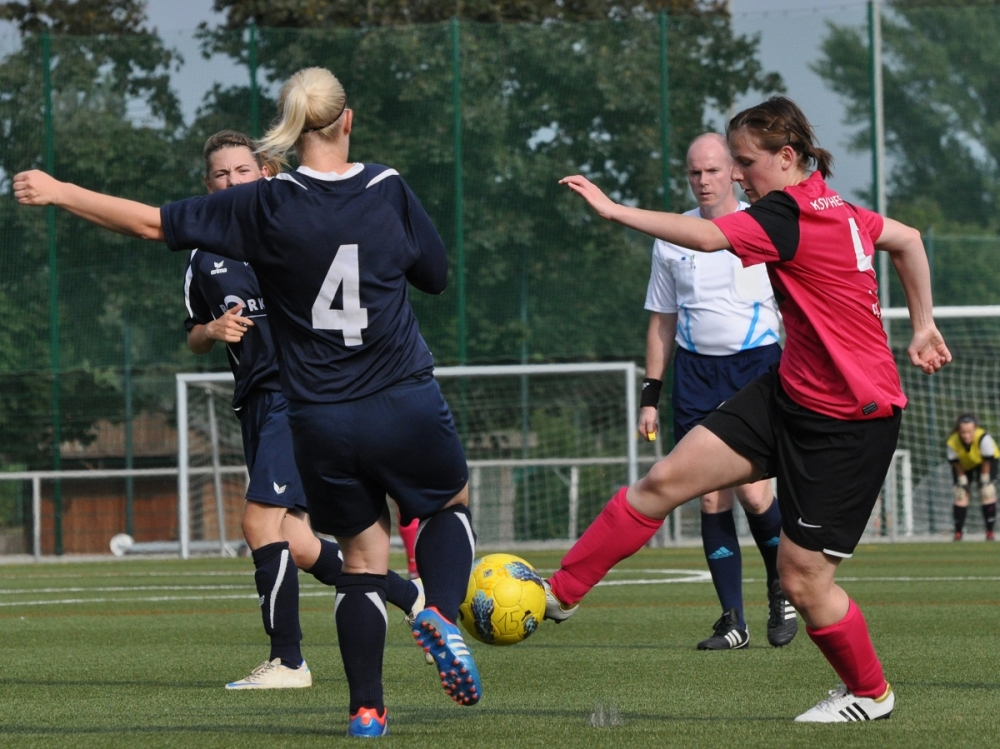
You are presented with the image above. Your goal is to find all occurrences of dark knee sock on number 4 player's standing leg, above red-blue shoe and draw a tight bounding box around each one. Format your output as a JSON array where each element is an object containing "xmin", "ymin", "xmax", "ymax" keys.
[{"xmin": 333, "ymin": 575, "xmax": 388, "ymax": 715}]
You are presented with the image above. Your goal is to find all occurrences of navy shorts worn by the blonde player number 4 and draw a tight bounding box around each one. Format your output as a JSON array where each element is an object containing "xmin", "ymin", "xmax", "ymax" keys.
[{"xmin": 288, "ymin": 375, "xmax": 469, "ymax": 536}]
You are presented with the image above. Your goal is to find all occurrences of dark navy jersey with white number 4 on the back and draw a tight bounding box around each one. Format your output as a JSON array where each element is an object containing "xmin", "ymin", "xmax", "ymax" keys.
[{"xmin": 160, "ymin": 164, "xmax": 448, "ymax": 403}]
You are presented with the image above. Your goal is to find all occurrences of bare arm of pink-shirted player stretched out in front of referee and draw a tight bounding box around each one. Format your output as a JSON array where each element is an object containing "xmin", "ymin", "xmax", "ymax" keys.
[{"xmin": 559, "ymin": 175, "xmax": 731, "ymax": 252}]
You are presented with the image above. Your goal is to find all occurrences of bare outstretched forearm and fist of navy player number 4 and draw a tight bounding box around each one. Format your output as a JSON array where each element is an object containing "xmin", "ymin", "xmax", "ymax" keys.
[{"xmin": 14, "ymin": 169, "xmax": 164, "ymax": 242}]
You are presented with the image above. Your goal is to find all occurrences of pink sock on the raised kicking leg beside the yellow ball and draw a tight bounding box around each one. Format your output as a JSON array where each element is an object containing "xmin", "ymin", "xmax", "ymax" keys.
[{"xmin": 549, "ymin": 487, "xmax": 663, "ymax": 606}]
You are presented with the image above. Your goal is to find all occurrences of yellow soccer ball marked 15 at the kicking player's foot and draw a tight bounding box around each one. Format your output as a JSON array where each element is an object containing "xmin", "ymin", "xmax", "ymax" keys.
[{"xmin": 458, "ymin": 554, "xmax": 545, "ymax": 645}]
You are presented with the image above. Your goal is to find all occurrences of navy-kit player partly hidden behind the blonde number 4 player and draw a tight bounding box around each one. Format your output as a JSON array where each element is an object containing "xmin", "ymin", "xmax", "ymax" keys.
[{"xmin": 184, "ymin": 130, "xmax": 421, "ymax": 689}]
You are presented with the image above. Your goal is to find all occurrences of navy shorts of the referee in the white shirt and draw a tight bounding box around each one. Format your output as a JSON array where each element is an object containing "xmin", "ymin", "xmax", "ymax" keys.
[{"xmin": 671, "ymin": 343, "xmax": 781, "ymax": 442}]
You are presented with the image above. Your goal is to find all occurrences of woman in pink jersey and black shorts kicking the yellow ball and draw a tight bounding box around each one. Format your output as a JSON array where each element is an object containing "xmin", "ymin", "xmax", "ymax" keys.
[{"xmin": 546, "ymin": 97, "xmax": 951, "ymax": 723}]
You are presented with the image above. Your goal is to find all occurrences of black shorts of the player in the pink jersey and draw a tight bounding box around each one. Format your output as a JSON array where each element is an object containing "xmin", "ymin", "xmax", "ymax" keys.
[{"xmin": 702, "ymin": 366, "xmax": 903, "ymax": 557}]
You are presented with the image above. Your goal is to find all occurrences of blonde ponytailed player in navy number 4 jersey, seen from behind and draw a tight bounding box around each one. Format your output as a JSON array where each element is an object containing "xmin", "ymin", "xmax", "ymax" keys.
[{"xmin": 14, "ymin": 68, "xmax": 482, "ymax": 736}]
